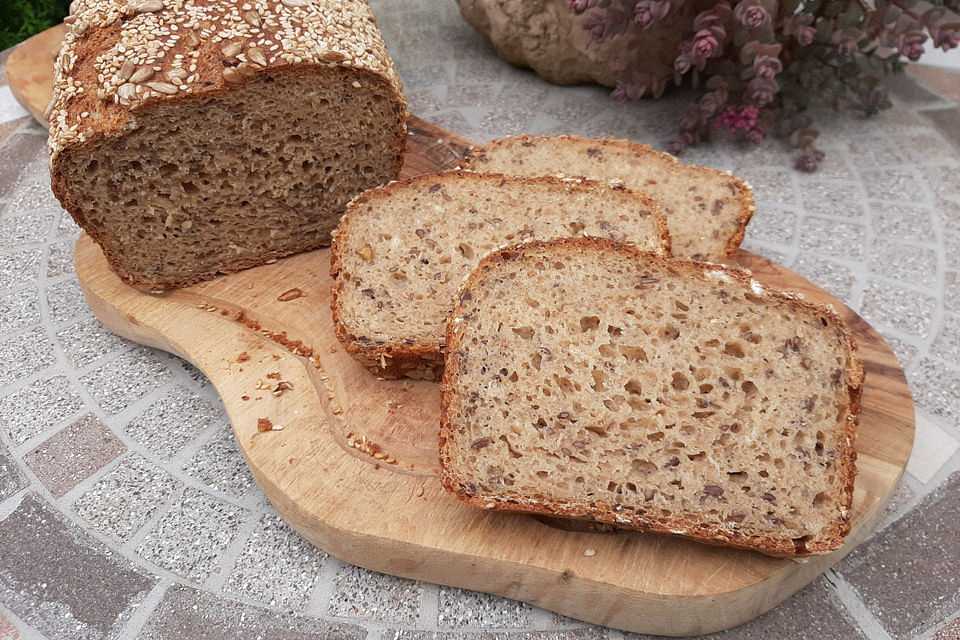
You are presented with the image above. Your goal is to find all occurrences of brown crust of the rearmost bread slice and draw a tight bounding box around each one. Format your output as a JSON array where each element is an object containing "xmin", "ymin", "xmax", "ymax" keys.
[{"xmin": 461, "ymin": 134, "xmax": 756, "ymax": 256}]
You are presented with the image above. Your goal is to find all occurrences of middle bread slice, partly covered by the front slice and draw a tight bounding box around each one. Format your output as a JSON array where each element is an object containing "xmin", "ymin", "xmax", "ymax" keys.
[{"xmin": 331, "ymin": 171, "xmax": 669, "ymax": 380}]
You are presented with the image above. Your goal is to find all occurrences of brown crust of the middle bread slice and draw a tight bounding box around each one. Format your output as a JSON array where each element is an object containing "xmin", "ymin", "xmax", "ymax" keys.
[{"xmin": 330, "ymin": 169, "xmax": 670, "ymax": 381}]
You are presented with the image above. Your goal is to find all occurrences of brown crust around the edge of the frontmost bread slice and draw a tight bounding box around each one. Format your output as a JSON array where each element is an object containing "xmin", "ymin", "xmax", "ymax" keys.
[{"xmin": 439, "ymin": 238, "xmax": 864, "ymax": 556}]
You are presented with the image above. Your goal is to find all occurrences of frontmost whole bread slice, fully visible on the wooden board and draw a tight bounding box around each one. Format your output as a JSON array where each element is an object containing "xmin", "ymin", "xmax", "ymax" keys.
[{"xmin": 440, "ymin": 239, "xmax": 863, "ymax": 555}]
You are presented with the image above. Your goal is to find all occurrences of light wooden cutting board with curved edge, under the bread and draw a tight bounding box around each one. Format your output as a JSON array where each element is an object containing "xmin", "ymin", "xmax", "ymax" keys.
[{"xmin": 7, "ymin": 23, "xmax": 914, "ymax": 635}]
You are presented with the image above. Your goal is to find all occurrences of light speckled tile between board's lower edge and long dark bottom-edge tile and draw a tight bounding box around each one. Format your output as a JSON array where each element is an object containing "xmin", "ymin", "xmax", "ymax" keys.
[{"xmin": 224, "ymin": 513, "xmax": 327, "ymax": 610}]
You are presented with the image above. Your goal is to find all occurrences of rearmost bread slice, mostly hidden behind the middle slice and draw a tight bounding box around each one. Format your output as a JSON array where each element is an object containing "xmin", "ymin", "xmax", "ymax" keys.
[{"xmin": 462, "ymin": 136, "xmax": 754, "ymax": 260}]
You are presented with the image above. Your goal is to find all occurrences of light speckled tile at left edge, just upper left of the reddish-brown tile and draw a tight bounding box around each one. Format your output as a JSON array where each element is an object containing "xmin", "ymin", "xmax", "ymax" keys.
[{"xmin": 0, "ymin": 376, "xmax": 83, "ymax": 444}]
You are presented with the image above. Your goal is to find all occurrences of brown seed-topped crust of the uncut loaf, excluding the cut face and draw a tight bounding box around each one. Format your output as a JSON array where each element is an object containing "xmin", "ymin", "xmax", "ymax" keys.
[{"xmin": 47, "ymin": 0, "xmax": 407, "ymax": 290}]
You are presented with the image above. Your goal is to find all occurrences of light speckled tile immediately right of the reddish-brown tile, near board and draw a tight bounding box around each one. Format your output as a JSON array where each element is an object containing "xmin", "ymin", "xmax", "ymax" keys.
[{"xmin": 124, "ymin": 386, "xmax": 226, "ymax": 460}]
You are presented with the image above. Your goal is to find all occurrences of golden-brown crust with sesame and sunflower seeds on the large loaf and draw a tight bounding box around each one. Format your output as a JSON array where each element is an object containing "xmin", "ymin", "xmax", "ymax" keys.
[{"xmin": 47, "ymin": 0, "xmax": 406, "ymax": 290}]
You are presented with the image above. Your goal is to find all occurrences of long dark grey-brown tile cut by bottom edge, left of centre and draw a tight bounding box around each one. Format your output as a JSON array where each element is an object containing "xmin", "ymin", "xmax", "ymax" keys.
[{"xmin": 137, "ymin": 585, "xmax": 367, "ymax": 640}]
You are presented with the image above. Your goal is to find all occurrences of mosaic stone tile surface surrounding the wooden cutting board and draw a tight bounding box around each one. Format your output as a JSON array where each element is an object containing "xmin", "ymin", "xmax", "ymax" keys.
[{"xmin": 0, "ymin": 0, "xmax": 960, "ymax": 640}]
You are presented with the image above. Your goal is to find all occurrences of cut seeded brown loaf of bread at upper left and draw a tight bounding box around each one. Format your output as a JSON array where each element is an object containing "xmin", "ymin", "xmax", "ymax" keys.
[{"xmin": 47, "ymin": 0, "xmax": 406, "ymax": 289}]
